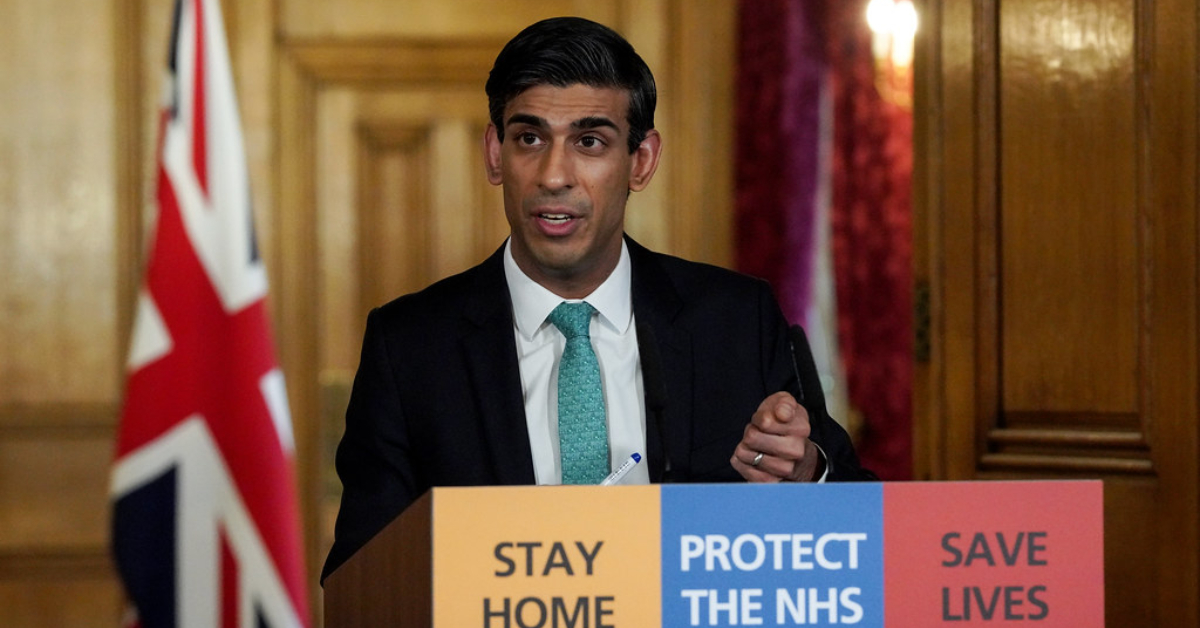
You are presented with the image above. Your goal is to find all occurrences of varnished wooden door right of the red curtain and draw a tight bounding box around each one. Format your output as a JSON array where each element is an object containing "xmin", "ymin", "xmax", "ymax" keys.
[{"xmin": 914, "ymin": 0, "xmax": 1200, "ymax": 628}]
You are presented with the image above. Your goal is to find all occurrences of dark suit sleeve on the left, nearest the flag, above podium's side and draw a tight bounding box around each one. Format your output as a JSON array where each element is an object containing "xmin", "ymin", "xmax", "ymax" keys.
[{"xmin": 320, "ymin": 310, "xmax": 420, "ymax": 581}]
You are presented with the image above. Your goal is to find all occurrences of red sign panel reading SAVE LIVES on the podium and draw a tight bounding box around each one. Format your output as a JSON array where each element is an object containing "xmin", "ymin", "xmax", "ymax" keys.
[{"xmin": 883, "ymin": 482, "xmax": 1104, "ymax": 628}]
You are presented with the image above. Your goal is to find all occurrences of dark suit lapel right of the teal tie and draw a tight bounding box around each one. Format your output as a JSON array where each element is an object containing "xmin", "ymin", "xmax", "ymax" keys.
[{"xmin": 625, "ymin": 238, "xmax": 694, "ymax": 483}]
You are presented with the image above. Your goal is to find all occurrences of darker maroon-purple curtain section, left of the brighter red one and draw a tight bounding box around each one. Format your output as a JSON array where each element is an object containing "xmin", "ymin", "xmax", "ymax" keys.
[{"xmin": 736, "ymin": 0, "xmax": 829, "ymax": 317}]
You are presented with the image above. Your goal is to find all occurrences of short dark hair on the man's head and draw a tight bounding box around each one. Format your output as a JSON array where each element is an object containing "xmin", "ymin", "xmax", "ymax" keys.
[{"xmin": 485, "ymin": 17, "xmax": 658, "ymax": 152}]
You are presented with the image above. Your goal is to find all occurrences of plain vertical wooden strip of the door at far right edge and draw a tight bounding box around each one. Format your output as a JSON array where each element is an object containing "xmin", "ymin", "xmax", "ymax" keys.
[{"xmin": 1135, "ymin": 0, "xmax": 1200, "ymax": 626}]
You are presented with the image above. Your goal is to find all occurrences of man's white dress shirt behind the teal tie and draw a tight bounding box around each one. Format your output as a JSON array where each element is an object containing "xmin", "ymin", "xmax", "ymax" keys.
[{"xmin": 504, "ymin": 243, "xmax": 650, "ymax": 484}]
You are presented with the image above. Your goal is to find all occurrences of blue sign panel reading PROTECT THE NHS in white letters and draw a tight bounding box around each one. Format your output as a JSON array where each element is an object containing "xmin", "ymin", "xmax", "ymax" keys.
[{"xmin": 661, "ymin": 484, "xmax": 883, "ymax": 628}]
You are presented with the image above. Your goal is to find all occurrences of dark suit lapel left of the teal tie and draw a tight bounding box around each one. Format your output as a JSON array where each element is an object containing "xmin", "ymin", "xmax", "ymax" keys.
[{"xmin": 461, "ymin": 246, "xmax": 536, "ymax": 484}]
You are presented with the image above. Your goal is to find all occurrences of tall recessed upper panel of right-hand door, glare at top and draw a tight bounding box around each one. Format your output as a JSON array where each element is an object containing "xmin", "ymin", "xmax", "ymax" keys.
[{"xmin": 998, "ymin": 0, "xmax": 1141, "ymax": 412}]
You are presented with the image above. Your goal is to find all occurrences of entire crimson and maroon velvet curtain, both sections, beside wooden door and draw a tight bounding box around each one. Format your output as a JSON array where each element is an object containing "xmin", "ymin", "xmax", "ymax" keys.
[{"xmin": 736, "ymin": 0, "xmax": 913, "ymax": 480}]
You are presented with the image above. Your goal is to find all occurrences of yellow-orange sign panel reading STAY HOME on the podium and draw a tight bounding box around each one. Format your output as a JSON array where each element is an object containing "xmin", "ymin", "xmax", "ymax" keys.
[{"xmin": 433, "ymin": 486, "xmax": 660, "ymax": 628}]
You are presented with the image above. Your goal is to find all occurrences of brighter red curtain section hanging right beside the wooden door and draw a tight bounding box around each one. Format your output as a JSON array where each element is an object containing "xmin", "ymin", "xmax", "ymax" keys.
[{"xmin": 830, "ymin": 0, "xmax": 913, "ymax": 479}]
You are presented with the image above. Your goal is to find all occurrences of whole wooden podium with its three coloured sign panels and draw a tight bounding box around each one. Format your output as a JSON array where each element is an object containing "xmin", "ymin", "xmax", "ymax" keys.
[{"xmin": 325, "ymin": 480, "xmax": 1104, "ymax": 628}]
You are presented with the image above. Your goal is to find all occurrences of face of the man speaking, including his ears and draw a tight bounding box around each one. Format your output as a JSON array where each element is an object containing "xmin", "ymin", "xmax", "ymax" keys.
[{"xmin": 485, "ymin": 85, "xmax": 660, "ymax": 298}]
